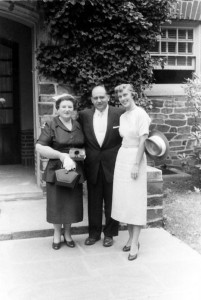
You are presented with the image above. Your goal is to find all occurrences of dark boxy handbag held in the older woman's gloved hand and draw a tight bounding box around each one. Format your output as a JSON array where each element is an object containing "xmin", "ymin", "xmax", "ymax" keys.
[{"xmin": 55, "ymin": 169, "xmax": 80, "ymax": 189}]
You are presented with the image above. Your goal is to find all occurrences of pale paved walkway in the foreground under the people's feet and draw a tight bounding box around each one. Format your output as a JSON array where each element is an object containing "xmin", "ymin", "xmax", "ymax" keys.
[{"xmin": 0, "ymin": 228, "xmax": 201, "ymax": 300}]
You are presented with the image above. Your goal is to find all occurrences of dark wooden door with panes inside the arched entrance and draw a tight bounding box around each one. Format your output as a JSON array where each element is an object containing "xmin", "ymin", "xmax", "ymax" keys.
[{"xmin": 0, "ymin": 38, "xmax": 20, "ymax": 165}]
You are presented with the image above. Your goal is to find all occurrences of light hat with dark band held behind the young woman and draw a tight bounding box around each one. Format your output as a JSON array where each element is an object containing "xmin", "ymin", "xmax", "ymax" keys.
[{"xmin": 145, "ymin": 129, "xmax": 169, "ymax": 159}]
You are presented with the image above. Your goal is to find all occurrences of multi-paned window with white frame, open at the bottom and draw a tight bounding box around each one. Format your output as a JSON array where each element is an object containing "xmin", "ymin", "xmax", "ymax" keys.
[{"xmin": 150, "ymin": 28, "xmax": 195, "ymax": 83}]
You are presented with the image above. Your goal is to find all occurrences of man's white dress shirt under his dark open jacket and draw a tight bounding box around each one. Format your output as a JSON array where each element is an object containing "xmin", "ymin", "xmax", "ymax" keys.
[{"xmin": 93, "ymin": 105, "xmax": 109, "ymax": 147}]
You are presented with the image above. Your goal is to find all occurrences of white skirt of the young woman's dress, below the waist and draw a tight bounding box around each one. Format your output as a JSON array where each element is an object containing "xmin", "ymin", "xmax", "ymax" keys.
[{"xmin": 111, "ymin": 147, "xmax": 147, "ymax": 225}]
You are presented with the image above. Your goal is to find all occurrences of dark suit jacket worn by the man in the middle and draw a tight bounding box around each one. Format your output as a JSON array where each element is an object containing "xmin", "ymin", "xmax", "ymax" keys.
[{"xmin": 79, "ymin": 106, "xmax": 124, "ymax": 184}]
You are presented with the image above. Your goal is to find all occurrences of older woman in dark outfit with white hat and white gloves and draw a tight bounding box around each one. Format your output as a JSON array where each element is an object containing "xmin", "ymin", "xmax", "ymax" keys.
[{"xmin": 36, "ymin": 95, "xmax": 84, "ymax": 250}]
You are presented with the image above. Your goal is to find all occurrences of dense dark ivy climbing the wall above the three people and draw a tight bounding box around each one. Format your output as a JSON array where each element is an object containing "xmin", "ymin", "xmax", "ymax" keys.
[{"xmin": 37, "ymin": 0, "xmax": 174, "ymax": 108}]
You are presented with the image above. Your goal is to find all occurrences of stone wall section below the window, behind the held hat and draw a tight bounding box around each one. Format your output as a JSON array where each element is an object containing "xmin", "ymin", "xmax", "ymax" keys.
[{"xmin": 149, "ymin": 96, "xmax": 194, "ymax": 165}]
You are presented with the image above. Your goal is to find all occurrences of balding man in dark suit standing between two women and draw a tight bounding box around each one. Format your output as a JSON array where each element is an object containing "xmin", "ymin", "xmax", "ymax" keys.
[{"xmin": 79, "ymin": 86, "xmax": 124, "ymax": 247}]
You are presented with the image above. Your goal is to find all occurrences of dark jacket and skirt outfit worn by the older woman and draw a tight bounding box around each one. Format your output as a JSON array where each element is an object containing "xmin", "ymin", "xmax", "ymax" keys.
[{"xmin": 37, "ymin": 117, "xmax": 84, "ymax": 224}]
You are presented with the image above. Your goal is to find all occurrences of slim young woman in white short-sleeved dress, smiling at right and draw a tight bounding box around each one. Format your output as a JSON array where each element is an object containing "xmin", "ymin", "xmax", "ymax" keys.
[{"xmin": 112, "ymin": 84, "xmax": 151, "ymax": 260}]
